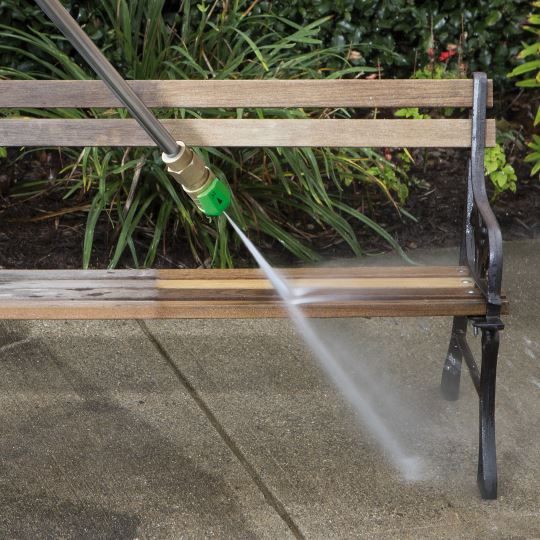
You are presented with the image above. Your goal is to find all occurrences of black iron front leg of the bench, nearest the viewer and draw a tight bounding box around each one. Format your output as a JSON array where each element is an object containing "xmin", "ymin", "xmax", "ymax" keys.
[{"xmin": 478, "ymin": 329, "xmax": 499, "ymax": 499}]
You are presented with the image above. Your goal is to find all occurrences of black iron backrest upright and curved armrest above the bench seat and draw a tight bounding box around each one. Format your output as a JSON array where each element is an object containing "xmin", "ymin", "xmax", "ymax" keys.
[{"xmin": 462, "ymin": 73, "xmax": 503, "ymax": 323}]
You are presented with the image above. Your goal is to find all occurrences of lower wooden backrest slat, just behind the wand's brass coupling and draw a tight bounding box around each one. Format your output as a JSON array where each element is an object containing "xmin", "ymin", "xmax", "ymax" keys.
[{"xmin": 0, "ymin": 119, "xmax": 495, "ymax": 148}]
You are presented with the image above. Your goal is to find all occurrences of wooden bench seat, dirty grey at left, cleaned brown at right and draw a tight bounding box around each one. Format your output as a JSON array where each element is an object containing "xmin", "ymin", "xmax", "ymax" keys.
[{"xmin": 0, "ymin": 267, "xmax": 508, "ymax": 319}]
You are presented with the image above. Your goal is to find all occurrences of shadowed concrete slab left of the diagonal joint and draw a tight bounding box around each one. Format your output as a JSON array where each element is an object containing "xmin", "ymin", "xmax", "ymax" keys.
[{"xmin": 0, "ymin": 321, "xmax": 292, "ymax": 539}]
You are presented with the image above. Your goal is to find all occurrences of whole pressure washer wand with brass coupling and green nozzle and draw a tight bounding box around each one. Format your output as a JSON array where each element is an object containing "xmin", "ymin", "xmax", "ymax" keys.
[{"xmin": 35, "ymin": 0, "xmax": 231, "ymax": 216}]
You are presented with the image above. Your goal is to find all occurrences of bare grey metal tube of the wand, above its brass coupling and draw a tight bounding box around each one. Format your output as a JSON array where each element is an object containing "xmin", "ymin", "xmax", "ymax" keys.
[{"xmin": 35, "ymin": 0, "xmax": 180, "ymax": 157}]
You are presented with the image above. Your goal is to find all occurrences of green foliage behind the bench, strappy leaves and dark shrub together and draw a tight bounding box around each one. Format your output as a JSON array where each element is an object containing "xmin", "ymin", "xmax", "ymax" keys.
[{"xmin": 0, "ymin": 0, "xmax": 530, "ymax": 267}]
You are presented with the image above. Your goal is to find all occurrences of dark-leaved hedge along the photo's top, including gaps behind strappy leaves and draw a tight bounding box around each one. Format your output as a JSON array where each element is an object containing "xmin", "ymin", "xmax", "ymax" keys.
[{"xmin": 0, "ymin": 0, "xmax": 530, "ymax": 84}]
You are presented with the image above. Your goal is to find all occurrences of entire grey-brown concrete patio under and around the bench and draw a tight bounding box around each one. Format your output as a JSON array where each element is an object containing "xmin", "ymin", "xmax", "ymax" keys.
[{"xmin": 0, "ymin": 242, "xmax": 540, "ymax": 539}]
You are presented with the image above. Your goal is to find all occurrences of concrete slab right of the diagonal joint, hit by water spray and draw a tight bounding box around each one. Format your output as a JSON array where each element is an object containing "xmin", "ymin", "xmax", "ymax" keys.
[{"xmin": 144, "ymin": 244, "xmax": 540, "ymax": 538}]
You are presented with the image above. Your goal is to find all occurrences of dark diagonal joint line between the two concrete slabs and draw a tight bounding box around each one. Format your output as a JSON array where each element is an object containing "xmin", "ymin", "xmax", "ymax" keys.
[{"xmin": 137, "ymin": 320, "xmax": 305, "ymax": 539}]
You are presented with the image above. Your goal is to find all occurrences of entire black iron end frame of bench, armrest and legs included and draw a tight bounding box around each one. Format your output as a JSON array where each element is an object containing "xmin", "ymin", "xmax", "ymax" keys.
[{"xmin": 441, "ymin": 73, "xmax": 504, "ymax": 499}]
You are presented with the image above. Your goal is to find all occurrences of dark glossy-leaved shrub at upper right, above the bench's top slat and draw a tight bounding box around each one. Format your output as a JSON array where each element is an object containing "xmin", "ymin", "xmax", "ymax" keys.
[{"xmin": 268, "ymin": 0, "xmax": 528, "ymax": 81}]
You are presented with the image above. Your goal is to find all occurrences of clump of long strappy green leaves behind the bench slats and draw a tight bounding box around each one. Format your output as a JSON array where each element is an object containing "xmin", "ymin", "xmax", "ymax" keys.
[{"xmin": 0, "ymin": 0, "xmax": 414, "ymax": 268}]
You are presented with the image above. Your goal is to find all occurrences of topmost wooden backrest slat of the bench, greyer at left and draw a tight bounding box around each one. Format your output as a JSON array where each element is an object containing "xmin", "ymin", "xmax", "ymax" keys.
[{"xmin": 0, "ymin": 79, "xmax": 493, "ymax": 108}]
